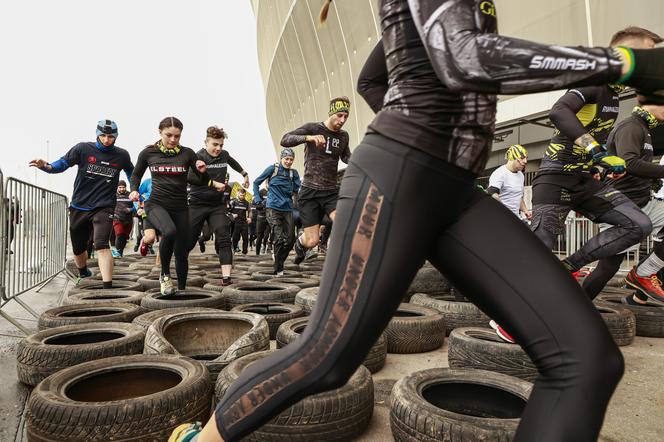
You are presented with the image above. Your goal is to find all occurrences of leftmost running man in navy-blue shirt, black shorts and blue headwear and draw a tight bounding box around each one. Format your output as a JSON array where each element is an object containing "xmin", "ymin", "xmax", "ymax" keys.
[{"xmin": 30, "ymin": 120, "xmax": 134, "ymax": 288}]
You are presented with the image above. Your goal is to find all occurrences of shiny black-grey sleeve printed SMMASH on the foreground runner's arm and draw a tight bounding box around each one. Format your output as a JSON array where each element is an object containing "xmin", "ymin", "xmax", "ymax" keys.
[{"xmin": 408, "ymin": 0, "xmax": 622, "ymax": 94}]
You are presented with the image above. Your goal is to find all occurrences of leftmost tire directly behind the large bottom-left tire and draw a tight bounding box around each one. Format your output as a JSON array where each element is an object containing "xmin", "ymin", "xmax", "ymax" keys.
[{"xmin": 16, "ymin": 322, "xmax": 145, "ymax": 385}]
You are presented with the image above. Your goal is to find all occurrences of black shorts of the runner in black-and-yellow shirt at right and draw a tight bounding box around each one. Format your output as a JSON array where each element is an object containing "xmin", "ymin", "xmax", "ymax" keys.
[{"xmin": 531, "ymin": 173, "xmax": 631, "ymax": 234}]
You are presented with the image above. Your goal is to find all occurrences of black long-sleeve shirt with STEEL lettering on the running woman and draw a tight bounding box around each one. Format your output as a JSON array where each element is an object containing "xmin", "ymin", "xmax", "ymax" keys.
[{"xmin": 131, "ymin": 144, "xmax": 212, "ymax": 210}]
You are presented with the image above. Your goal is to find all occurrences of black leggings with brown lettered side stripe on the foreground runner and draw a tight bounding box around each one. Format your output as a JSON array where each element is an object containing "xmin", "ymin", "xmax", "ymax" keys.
[{"xmin": 215, "ymin": 135, "xmax": 623, "ymax": 442}]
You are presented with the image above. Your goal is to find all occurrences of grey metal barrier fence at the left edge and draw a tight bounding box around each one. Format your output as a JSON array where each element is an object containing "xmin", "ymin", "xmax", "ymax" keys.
[{"xmin": 0, "ymin": 173, "xmax": 69, "ymax": 333}]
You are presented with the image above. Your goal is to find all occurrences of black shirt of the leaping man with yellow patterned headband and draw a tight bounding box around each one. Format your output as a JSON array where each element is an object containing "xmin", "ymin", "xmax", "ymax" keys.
[{"xmin": 281, "ymin": 123, "xmax": 350, "ymax": 190}]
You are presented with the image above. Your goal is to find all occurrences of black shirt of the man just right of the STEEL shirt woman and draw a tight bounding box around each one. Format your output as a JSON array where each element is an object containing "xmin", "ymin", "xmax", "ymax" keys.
[{"xmin": 188, "ymin": 149, "xmax": 244, "ymax": 206}]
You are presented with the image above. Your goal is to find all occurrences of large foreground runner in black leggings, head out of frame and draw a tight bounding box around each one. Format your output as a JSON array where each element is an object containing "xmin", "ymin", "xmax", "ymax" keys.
[{"xmin": 172, "ymin": 0, "xmax": 664, "ymax": 442}]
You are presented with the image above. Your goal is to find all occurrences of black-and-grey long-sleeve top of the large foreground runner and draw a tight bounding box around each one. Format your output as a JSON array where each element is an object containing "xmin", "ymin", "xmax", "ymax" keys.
[{"xmin": 363, "ymin": 0, "xmax": 622, "ymax": 174}]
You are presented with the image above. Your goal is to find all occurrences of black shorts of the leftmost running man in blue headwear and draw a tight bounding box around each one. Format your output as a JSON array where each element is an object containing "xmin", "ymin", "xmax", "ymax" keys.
[{"xmin": 69, "ymin": 207, "xmax": 115, "ymax": 255}]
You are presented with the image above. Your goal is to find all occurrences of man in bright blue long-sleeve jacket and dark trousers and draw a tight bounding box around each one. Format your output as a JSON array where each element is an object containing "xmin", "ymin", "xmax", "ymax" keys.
[{"xmin": 254, "ymin": 147, "xmax": 300, "ymax": 275}]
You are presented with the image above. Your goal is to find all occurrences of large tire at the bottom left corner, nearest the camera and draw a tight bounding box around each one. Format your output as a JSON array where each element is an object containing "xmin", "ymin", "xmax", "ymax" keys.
[{"xmin": 26, "ymin": 355, "xmax": 213, "ymax": 442}]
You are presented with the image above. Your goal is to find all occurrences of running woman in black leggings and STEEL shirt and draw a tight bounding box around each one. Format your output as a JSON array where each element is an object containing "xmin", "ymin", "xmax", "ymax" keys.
[{"xmin": 130, "ymin": 117, "xmax": 224, "ymax": 294}]
